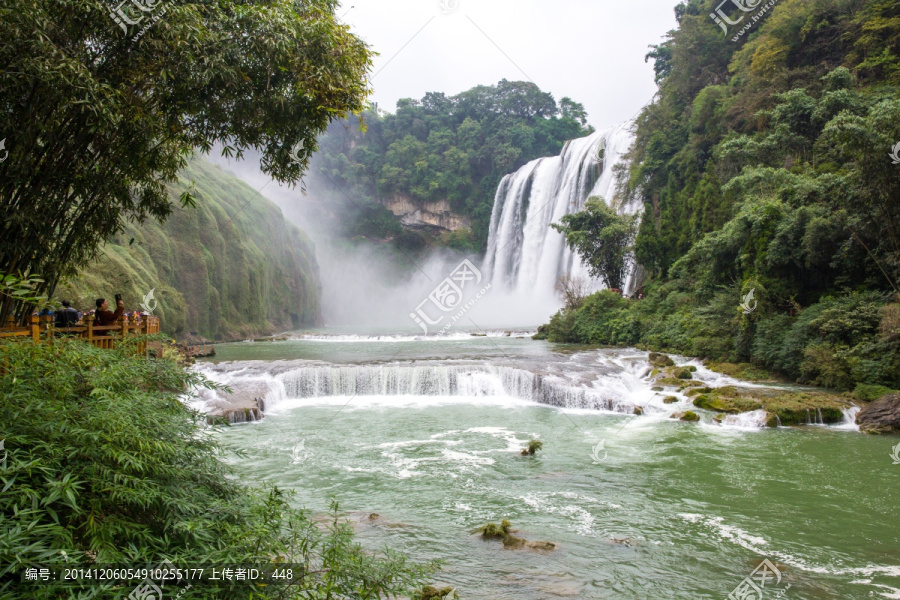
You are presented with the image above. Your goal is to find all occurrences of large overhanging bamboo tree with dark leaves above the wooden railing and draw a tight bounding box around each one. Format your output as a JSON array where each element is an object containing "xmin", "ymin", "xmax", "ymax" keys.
[{"xmin": 0, "ymin": 0, "xmax": 371, "ymax": 316}]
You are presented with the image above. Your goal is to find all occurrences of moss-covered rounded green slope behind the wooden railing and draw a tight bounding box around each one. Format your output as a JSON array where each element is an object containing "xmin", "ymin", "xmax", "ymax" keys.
[{"xmin": 56, "ymin": 159, "xmax": 320, "ymax": 341}]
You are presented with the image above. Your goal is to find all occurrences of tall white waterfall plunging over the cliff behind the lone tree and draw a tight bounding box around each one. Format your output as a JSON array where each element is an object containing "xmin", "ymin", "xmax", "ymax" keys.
[{"xmin": 484, "ymin": 123, "xmax": 633, "ymax": 296}]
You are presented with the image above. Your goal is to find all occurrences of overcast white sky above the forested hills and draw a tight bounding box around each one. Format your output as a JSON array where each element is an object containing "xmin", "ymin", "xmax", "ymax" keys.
[{"xmin": 337, "ymin": 0, "xmax": 678, "ymax": 129}]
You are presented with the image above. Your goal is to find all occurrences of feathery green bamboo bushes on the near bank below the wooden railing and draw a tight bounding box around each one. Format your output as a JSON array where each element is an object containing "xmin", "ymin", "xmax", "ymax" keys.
[{"xmin": 0, "ymin": 341, "xmax": 434, "ymax": 600}]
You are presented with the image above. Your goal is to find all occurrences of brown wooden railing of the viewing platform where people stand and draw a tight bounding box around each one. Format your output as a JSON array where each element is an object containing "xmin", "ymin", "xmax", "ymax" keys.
[{"xmin": 0, "ymin": 315, "xmax": 159, "ymax": 350}]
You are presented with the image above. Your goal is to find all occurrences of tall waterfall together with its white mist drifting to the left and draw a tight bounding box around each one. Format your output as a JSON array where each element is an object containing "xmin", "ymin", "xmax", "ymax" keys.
[{"xmin": 210, "ymin": 123, "xmax": 632, "ymax": 334}]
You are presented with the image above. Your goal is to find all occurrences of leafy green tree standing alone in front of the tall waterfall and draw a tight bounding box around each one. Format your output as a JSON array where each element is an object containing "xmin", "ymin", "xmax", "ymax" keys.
[{"xmin": 551, "ymin": 196, "xmax": 637, "ymax": 289}]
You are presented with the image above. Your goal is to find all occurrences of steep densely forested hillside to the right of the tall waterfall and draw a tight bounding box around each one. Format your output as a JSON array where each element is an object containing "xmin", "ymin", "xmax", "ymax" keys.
[{"xmin": 536, "ymin": 0, "xmax": 900, "ymax": 388}]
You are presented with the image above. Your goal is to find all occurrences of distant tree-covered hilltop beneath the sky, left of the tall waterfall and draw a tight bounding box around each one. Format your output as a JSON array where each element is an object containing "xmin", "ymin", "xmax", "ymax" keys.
[{"xmin": 313, "ymin": 80, "xmax": 593, "ymax": 250}]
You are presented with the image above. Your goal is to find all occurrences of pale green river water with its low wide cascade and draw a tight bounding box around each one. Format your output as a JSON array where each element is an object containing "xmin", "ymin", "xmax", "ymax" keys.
[{"xmin": 203, "ymin": 333, "xmax": 900, "ymax": 600}]
